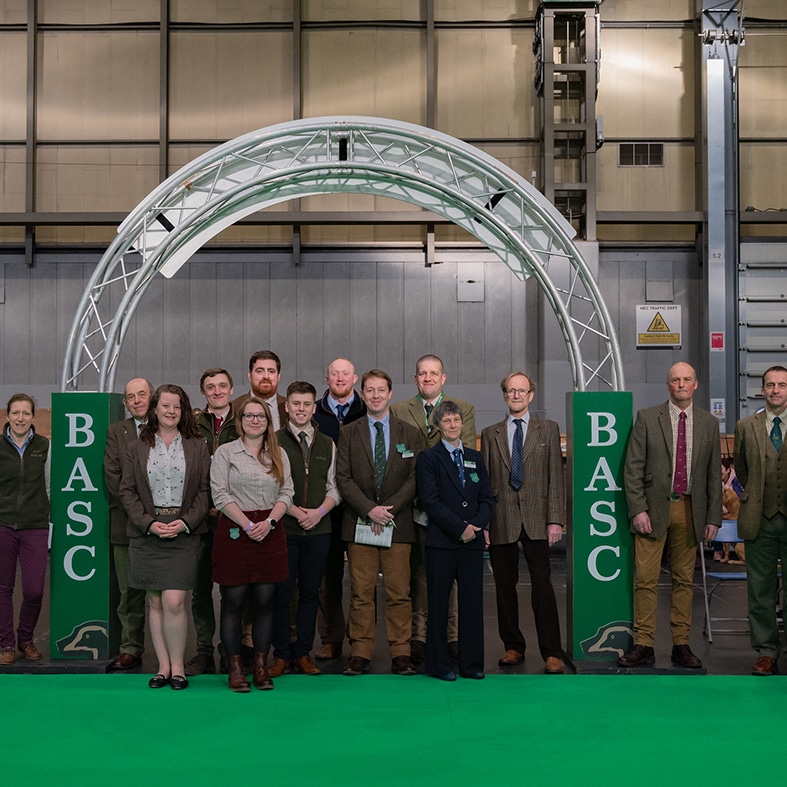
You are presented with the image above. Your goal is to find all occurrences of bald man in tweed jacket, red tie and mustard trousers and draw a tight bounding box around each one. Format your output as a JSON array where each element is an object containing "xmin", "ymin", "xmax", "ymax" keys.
[{"xmin": 618, "ymin": 363, "xmax": 721, "ymax": 669}]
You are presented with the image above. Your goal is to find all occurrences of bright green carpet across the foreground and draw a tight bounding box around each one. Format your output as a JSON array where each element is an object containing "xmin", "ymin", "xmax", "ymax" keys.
[{"xmin": 0, "ymin": 675, "xmax": 787, "ymax": 787}]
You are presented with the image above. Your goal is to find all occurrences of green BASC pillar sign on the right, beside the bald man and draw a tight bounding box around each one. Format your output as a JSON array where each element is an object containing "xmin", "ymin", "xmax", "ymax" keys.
[{"xmin": 566, "ymin": 391, "xmax": 634, "ymax": 661}]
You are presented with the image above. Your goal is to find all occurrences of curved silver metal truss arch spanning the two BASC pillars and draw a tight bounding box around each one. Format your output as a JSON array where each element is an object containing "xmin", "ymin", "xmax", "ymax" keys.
[{"xmin": 61, "ymin": 117, "xmax": 625, "ymax": 391}]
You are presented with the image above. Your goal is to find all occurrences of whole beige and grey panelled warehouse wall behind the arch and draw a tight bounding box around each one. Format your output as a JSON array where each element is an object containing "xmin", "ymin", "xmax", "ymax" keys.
[{"xmin": 0, "ymin": 0, "xmax": 787, "ymax": 425}]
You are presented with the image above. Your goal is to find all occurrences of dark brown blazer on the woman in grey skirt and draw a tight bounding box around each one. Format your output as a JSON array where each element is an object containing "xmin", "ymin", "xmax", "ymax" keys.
[{"xmin": 120, "ymin": 437, "xmax": 210, "ymax": 538}]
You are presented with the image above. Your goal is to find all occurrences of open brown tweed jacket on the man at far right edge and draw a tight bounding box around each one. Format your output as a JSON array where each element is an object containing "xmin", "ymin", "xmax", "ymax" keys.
[{"xmin": 733, "ymin": 410, "xmax": 785, "ymax": 540}]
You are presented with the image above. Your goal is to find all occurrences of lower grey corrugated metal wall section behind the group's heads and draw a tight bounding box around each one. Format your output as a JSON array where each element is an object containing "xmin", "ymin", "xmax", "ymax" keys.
[{"xmin": 0, "ymin": 247, "xmax": 703, "ymax": 428}]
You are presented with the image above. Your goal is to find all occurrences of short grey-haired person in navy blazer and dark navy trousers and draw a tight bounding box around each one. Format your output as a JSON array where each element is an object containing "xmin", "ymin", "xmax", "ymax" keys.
[{"xmin": 416, "ymin": 400, "xmax": 493, "ymax": 681}]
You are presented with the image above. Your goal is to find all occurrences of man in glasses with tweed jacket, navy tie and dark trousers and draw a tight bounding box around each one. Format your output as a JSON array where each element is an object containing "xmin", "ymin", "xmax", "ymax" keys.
[{"xmin": 481, "ymin": 372, "xmax": 565, "ymax": 675}]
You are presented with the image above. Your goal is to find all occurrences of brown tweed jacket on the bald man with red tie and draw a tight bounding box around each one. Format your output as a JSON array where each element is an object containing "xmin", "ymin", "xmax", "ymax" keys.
[{"xmin": 623, "ymin": 402, "xmax": 721, "ymax": 541}]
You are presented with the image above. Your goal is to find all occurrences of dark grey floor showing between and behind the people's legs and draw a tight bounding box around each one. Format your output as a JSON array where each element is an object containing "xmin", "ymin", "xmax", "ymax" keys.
[{"xmin": 0, "ymin": 546, "xmax": 756, "ymax": 675}]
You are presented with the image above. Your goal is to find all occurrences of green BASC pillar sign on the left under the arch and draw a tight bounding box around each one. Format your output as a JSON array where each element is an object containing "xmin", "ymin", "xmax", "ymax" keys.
[{"xmin": 50, "ymin": 393, "xmax": 124, "ymax": 660}]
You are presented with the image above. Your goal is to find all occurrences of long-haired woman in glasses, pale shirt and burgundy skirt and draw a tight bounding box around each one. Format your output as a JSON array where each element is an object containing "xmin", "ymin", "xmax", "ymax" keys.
[{"xmin": 210, "ymin": 396, "xmax": 294, "ymax": 691}]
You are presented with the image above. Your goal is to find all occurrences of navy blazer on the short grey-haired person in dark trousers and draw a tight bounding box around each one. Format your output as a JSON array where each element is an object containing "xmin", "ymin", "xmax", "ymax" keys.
[{"xmin": 415, "ymin": 442, "xmax": 494, "ymax": 550}]
